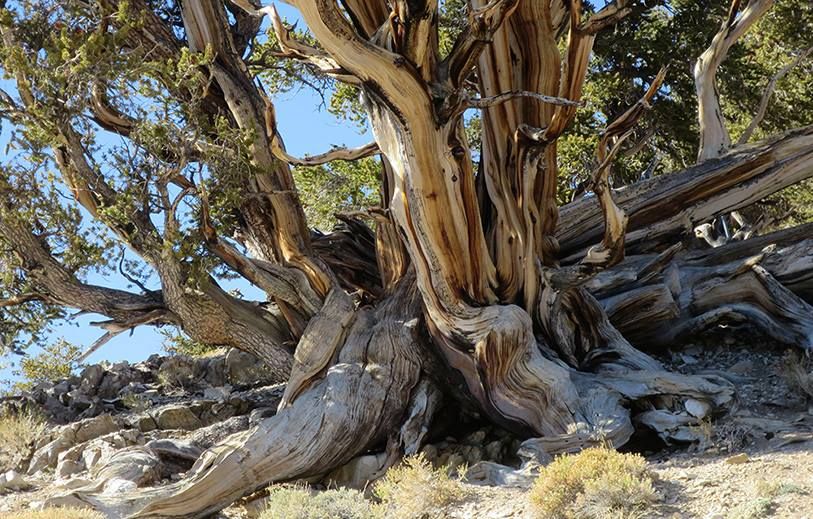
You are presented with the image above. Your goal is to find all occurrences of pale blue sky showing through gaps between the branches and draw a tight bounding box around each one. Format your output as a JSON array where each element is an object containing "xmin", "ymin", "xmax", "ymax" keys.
[{"xmin": 0, "ymin": 3, "xmax": 371, "ymax": 381}]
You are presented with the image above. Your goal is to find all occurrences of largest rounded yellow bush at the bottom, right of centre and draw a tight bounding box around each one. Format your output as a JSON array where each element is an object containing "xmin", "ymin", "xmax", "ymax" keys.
[{"xmin": 530, "ymin": 448, "xmax": 657, "ymax": 519}]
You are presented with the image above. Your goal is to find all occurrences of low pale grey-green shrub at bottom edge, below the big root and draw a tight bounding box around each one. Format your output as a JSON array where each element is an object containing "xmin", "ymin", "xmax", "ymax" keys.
[{"xmin": 260, "ymin": 486, "xmax": 383, "ymax": 519}]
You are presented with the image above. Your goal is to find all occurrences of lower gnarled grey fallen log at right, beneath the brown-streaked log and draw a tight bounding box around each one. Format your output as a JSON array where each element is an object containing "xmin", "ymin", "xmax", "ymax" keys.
[{"xmin": 588, "ymin": 225, "xmax": 813, "ymax": 349}]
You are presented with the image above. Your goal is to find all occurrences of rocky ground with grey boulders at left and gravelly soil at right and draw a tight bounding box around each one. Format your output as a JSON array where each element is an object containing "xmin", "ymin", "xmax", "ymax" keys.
[{"xmin": 0, "ymin": 334, "xmax": 813, "ymax": 519}]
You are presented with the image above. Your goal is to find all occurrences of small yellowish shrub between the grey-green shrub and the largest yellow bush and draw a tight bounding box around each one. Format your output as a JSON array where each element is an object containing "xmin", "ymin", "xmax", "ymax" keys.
[{"xmin": 373, "ymin": 454, "xmax": 466, "ymax": 519}]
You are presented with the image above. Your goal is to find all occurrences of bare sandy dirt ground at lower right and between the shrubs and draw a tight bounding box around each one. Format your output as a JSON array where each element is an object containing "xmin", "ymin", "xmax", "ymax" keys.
[{"xmin": 0, "ymin": 334, "xmax": 813, "ymax": 519}]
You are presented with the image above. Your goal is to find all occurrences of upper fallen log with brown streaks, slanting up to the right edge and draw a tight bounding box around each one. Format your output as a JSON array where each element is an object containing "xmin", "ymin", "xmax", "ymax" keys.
[{"xmin": 556, "ymin": 126, "xmax": 813, "ymax": 261}]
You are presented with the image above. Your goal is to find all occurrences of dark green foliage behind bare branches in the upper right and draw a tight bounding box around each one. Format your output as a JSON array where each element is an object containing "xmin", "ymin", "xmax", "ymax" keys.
[{"xmin": 558, "ymin": 0, "xmax": 813, "ymax": 207}]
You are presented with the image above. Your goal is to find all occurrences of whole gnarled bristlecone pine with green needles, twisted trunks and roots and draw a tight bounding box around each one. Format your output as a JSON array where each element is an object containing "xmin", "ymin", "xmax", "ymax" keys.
[{"xmin": 0, "ymin": 0, "xmax": 813, "ymax": 517}]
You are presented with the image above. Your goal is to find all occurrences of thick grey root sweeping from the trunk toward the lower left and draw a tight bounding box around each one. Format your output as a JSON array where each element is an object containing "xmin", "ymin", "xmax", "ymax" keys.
[{"xmin": 46, "ymin": 283, "xmax": 423, "ymax": 518}]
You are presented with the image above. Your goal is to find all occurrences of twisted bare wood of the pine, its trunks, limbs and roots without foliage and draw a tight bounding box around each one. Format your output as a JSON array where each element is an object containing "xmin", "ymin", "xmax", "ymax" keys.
[{"xmin": 0, "ymin": 0, "xmax": 813, "ymax": 517}]
